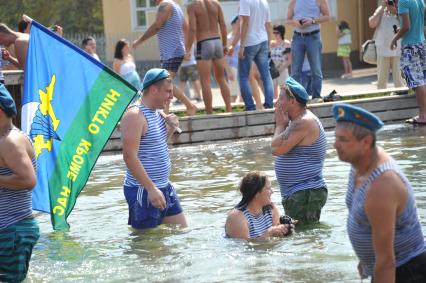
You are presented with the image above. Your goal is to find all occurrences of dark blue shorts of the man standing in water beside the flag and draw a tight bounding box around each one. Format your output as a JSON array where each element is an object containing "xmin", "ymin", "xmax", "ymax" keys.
[{"xmin": 124, "ymin": 183, "xmax": 183, "ymax": 229}]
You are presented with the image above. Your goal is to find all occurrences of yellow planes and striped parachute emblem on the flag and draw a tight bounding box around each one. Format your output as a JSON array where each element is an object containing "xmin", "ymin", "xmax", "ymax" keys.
[{"xmin": 30, "ymin": 75, "xmax": 61, "ymax": 158}]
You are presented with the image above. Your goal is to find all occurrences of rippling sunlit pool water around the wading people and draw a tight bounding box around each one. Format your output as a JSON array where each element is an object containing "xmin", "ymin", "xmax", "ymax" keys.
[{"xmin": 26, "ymin": 125, "xmax": 426, "ymax": 282}]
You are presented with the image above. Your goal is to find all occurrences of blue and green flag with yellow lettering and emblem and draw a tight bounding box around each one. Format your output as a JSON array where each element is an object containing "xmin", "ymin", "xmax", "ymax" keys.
[{"xmin": 22, "ymin": 21, "xmax": 137, "ymax": 230}]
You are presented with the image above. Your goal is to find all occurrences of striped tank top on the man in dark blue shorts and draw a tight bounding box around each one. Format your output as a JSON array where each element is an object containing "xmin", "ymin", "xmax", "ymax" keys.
[{"xmin": 124, "ymin": 105, "xmax": 171, "ymax": 188}]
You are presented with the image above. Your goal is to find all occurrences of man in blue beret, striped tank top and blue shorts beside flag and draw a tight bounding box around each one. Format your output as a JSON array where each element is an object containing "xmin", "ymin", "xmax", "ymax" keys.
[{"xmin": 120, "ymin": 69, "xmax": 186, "ymax": 229}]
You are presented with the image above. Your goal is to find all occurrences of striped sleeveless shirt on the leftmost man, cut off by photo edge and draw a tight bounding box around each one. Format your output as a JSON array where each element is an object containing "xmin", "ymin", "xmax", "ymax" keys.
[{"xmin": 0, "ymin": 128, "xmax": 36, "ymax": 230}]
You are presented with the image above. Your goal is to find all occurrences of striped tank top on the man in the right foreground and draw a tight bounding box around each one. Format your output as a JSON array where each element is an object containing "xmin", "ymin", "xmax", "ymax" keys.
[{"xmin": 346, "ymin": 159, "xmax": 426, "ymax": 276}]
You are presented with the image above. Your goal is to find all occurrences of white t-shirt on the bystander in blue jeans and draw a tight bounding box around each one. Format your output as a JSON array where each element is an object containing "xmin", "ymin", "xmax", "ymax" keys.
[{"xmin": 240, "ymin": 0, "xmax": 271, "ymax": 46}]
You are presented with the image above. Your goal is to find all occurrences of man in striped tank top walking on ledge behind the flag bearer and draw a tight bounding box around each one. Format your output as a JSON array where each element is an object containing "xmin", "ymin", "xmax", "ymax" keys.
[{"xmin": 132, "ymin": 0, "xmax": 197, "ymax": 116}]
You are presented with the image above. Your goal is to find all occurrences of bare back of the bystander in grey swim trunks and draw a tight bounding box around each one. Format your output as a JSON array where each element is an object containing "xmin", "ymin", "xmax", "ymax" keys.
[{"xmin": 188, "ymin": 0, "xmax": 222, "ymax": 41}]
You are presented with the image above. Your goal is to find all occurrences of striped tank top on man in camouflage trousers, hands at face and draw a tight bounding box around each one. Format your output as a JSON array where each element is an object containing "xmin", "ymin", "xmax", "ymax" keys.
[{"xmin": 275, "ymin": 116, "xmax": 327, "ymax": 199}]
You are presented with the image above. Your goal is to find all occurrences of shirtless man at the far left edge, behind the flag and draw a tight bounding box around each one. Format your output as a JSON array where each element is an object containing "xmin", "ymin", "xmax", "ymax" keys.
[{"xmin": 0, "ymin": 23, "xmax": 30, "ymax": 70}]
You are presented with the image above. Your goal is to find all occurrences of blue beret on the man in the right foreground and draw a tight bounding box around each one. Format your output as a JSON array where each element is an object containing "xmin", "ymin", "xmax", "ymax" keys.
[{"xmin": 332, "ymin": 103, "xmax": 384, "ymax": 132}]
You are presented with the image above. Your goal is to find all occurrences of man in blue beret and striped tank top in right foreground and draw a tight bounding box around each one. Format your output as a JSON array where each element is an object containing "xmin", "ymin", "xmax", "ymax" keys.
[{"xmin": 333, "ymin": 104, "xmax": 426, "ymax": 283}]
